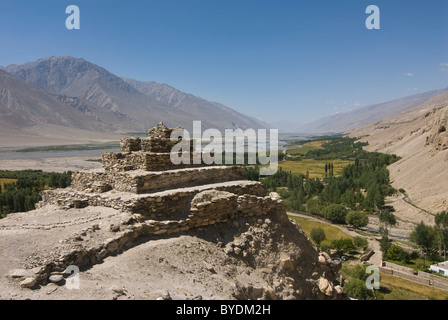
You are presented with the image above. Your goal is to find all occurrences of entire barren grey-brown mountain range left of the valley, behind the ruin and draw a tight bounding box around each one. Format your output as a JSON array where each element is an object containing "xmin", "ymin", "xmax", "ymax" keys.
[{"xmin": 0, "ymin": 57, "xmax": 266, "ymax": 146}]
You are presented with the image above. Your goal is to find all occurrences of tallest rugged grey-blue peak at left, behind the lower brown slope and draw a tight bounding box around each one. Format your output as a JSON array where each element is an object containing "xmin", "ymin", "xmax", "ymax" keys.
[{"xmin": 5, "ymin": 57, "xmax": 199, "ymax": 131}]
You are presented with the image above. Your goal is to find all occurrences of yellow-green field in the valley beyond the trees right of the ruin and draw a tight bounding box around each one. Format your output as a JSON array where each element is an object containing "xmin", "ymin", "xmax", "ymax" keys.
[{"xmin": 278, "ymin": 159, "xmax": 354, "ymax": 178}]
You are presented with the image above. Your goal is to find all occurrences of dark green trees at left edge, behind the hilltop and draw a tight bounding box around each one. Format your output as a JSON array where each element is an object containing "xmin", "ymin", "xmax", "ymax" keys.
[{"xmin": 0, "ymin": 170, "xmax": 71, "ymax": 217}]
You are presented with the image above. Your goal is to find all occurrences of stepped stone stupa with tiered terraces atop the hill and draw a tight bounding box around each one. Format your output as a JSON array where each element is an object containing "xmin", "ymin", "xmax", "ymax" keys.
[{"xmin": 39, "ymin": 123, "xmax": 274, "ymax": 222}]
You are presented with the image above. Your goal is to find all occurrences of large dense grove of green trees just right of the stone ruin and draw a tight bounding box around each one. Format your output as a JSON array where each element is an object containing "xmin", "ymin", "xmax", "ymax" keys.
[{"xmin": 244, "ymin": 138, "xmax": 398, "ymax": 227}]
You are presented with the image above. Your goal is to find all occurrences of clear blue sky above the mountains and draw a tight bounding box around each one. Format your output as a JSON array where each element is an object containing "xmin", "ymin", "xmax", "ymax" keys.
[{"xmin": 0, "ymin": 0, "xmax": 448, "ymax": 122}]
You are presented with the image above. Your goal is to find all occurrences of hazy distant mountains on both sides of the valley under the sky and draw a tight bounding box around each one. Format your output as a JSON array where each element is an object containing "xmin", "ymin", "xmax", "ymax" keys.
[{"xmin": 0, "ymin": 57, "xmax": 447, "ymax": 145}]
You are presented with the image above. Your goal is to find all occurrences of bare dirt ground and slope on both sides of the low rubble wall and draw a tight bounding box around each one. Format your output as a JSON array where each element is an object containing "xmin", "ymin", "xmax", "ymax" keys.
[{"xmin": 0, "ymin": 200, "xmax": 344, "ymax": 300}]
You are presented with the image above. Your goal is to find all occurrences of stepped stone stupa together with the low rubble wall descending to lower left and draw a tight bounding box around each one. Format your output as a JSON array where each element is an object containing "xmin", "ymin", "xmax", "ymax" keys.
[{"xmin": 12, "ymin": 123, "xmax": 342, "ymax": 299}]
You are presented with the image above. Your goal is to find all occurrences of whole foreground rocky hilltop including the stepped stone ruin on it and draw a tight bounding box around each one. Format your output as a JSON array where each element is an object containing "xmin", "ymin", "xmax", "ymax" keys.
[{"xmin": 0, "ymin": 123, "xmax": 345, "ymax": 299}]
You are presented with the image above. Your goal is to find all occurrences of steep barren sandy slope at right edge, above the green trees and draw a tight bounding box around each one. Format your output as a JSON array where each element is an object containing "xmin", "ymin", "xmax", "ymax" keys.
[{"xmin": 350, "ymin": 92, "xmax": 448, "ymax": 223}]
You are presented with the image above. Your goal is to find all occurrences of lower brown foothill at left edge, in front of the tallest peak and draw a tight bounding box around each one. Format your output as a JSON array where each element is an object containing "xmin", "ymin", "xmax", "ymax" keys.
[{"xmin": 0, "ymin": 70, "xmax": 127, "ymax": 147}]
